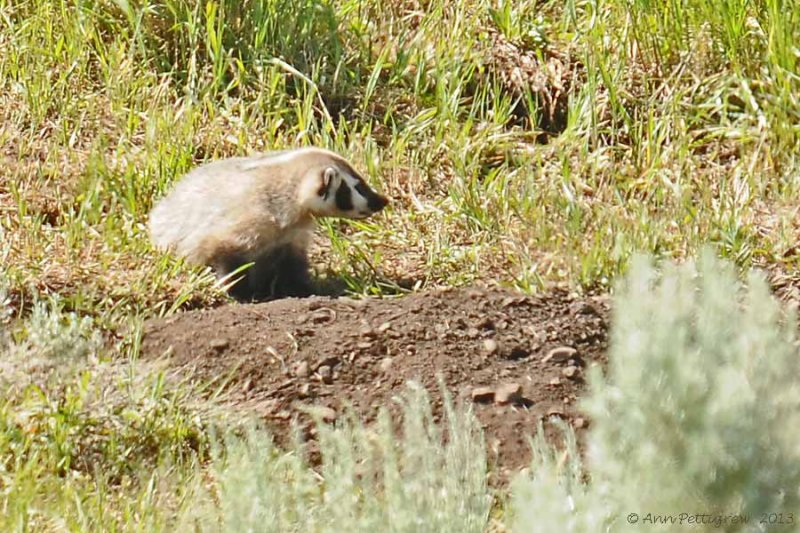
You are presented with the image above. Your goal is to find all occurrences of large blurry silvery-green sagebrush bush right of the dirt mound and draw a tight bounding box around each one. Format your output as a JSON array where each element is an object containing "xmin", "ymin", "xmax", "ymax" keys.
[{"xmin": 514, "ymin": 254, "xmax": 800, "ymax": 531}]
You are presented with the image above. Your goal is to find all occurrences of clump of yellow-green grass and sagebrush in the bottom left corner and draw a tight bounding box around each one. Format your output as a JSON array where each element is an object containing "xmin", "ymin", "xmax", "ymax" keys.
[{"xmin": 0, "ymin": 302, "xmax": 207, "ymax": 531}]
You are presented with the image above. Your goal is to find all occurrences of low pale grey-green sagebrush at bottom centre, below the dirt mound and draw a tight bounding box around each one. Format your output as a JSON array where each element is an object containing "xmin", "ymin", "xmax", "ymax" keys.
[{"xmin": 185, "ymin": 385, "xmax": 491, "ymax": 532}]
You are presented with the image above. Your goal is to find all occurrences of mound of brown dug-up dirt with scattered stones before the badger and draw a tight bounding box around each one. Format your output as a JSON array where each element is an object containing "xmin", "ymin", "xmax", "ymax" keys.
[{"xmin": 142, "ymin": 289, "xmax": 608, "ymax": 478}]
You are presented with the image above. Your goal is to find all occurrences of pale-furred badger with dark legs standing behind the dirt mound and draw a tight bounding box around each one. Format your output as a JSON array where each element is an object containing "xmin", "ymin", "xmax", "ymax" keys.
[{"xmin": 148, "ymin": 148, "xmax": 389, "ymax": 300}]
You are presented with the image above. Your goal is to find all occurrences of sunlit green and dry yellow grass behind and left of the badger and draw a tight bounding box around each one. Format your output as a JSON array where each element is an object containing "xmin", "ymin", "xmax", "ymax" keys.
[{"xmin": 0, "ymin": 0, "xmax": 800, "ymax": 530}]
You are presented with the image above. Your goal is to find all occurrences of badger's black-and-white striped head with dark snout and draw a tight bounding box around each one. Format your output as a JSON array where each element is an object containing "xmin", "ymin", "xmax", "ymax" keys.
[{"xmin": 303, "ymin": 162, "xmax": 389, "ymax": 219}]
